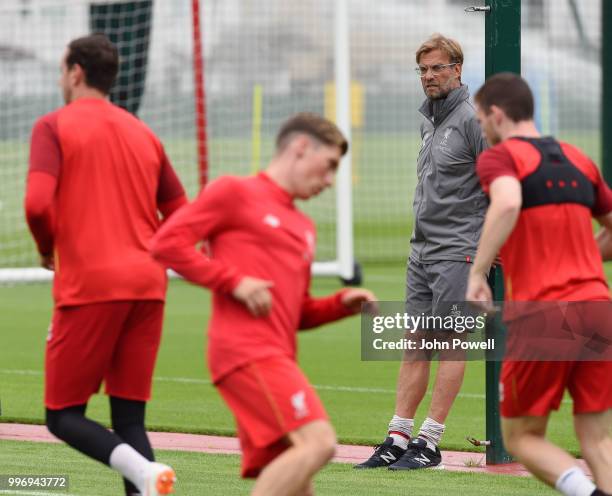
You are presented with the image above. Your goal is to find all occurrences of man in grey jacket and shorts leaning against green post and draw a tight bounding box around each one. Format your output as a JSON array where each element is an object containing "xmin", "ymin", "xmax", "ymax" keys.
[{"xmin": 355, "ymin": 33, "xmax": 487, "ymax": 470}]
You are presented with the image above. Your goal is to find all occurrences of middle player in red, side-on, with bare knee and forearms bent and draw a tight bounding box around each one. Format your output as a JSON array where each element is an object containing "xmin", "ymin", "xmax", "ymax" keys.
[{"xmin": 153, "ymin": 114, "xmax": 374, "ymax": 496}]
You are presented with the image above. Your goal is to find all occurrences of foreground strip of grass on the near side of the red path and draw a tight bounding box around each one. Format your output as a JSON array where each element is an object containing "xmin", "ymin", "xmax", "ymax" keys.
[{"xmin": 0, "ymin": 441, "xmax": 552, "ymax": 496}]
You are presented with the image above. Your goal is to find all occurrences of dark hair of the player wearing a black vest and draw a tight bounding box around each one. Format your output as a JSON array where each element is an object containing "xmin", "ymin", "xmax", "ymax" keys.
[{"xmin": 474, "ymin": 72, "xmax": 533, "ymax": 122}]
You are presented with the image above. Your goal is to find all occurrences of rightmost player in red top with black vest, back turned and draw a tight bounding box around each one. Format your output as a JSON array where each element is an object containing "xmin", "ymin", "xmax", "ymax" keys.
[{"xmin": 466, "ymin": 73, "xmax": 612, "ymax": 496}]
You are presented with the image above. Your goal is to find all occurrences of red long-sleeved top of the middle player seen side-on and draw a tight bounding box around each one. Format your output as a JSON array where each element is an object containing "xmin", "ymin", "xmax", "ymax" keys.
[{"xmin": 153, "ymin": 173, "xmax": 351, "ymax": 382}]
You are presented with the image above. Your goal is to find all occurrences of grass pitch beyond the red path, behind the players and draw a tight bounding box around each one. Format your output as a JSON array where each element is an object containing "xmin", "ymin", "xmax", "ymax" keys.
[{"xmin": 0, "ymin": 265, "xmax": 600, "ymax": 452}]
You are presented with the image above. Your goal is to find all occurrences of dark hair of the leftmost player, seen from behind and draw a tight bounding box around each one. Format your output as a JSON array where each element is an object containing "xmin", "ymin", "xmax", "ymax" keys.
[{"xmin": 66, "ymin": 33, "xmax": 119, "ymax": 95}]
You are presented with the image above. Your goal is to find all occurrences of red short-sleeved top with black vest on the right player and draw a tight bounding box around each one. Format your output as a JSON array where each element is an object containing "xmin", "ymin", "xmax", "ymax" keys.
[{"xmin": 476, "ymin": 138, "xmax": 612, "ymax": 301}]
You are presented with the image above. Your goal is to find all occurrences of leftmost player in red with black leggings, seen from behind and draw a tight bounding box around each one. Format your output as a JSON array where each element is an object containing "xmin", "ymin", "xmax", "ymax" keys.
[{"xmin": 25, "ymin": 35, "xmax": 186, "ymax": 495}]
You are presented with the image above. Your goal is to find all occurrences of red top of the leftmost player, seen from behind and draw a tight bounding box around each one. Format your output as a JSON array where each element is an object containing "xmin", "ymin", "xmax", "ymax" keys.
[{"xmin": 25, "ymin": 98, "xmax": 186, "ymax": 307}]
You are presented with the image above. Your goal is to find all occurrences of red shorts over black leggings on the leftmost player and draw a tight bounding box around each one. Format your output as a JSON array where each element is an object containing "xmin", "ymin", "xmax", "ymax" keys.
[{"xmin": 45, "ymin": 300, "xmax": 164, "ymax": 410}]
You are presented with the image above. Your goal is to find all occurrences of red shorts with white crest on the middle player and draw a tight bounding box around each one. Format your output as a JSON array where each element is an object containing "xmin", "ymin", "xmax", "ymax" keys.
[{"xmin": 217, "ymin": 356, "xmax": 328, "ymax": 477}]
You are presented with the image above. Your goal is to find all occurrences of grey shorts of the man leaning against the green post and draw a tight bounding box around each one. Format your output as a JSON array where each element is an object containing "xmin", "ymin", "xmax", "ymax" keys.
[{"xmin": 406, "ymin": 260, "xmax": 472, "ymax": 314}]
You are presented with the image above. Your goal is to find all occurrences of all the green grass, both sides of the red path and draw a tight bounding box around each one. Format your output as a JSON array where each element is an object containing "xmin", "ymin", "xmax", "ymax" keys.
[{"xmin": 0, "ymin": 264, "xmax": 612, "ymax": 496}]
